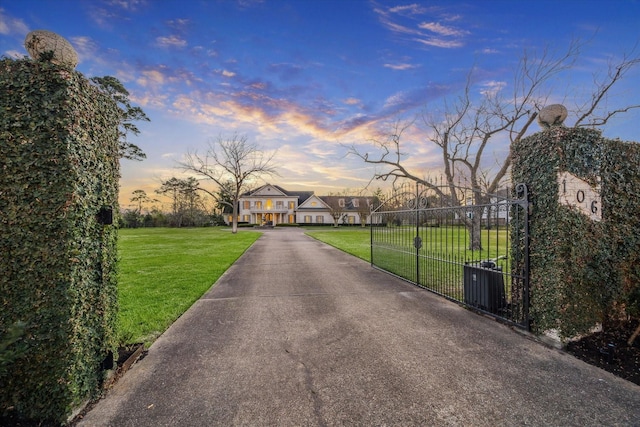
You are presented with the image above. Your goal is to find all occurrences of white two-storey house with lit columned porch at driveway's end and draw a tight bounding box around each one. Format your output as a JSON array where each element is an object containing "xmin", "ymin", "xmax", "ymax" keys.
[{"xmin": 234, "ymin": 184, "xmax": 372, "ymax": 225}]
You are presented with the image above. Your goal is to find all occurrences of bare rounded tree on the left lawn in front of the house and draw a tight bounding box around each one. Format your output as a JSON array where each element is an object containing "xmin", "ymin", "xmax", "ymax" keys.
[{"xmin": 180, "ymin": 135, "xmax": 277, "ymax": 233}]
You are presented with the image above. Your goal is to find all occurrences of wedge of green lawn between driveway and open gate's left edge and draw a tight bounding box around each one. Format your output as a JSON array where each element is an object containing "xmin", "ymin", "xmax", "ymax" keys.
[{"xmin": 305, "ymin": 227, "xmax": 371, "ymax": 262}]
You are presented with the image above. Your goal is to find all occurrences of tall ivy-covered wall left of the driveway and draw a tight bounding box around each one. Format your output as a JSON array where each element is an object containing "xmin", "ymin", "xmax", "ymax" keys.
[{"xmin": 0, "ymin": 59, "xmax": 119, "ymax": 423}]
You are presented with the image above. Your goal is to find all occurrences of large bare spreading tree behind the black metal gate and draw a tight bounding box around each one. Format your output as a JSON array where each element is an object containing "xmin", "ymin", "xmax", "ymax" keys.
[{"xmin": 350, "ymin": 41, "xmax": 640, "ymax": 250}]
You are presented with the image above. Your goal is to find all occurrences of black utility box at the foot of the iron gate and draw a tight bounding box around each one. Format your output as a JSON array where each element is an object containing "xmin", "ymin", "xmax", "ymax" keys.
[{"xmin": 464, "ymin": 261, "xmax": 506, "ymax": 314}]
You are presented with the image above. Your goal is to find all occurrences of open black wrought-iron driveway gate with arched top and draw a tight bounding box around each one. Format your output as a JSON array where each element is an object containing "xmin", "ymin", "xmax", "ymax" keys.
[{"xmin": 371, "ymin": 184, "xmax": 529, "ymax": 329}]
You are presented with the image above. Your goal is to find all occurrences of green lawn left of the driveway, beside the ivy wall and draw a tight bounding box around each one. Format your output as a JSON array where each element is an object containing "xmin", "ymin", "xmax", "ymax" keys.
[{"xmin": 118, "ymin": 227, "xmax": 260, "ymax": 345}]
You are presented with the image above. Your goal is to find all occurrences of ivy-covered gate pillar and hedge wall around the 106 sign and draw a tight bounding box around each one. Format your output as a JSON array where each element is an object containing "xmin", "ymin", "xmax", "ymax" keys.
[{"xmin": 512, "ymin": 127, "xmax": 640, "ymax": 338}]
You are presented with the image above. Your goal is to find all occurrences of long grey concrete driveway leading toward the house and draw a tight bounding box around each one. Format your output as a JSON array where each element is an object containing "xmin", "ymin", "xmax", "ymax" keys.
[{"xmin": 79, "ymin": 228, "xmax": 640, "ymax": 427}]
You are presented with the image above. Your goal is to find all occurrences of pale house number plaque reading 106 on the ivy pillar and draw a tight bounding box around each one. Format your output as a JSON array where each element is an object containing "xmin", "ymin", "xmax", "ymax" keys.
[{"xmin": 558, "ymin": 172, "xmax": 602, "ymax": 221}]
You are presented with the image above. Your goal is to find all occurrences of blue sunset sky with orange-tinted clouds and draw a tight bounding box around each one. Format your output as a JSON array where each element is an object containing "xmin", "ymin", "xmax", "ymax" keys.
[{"xmin": 0, "ymin": 0, "xmax": 640, "ymax": 208}]
